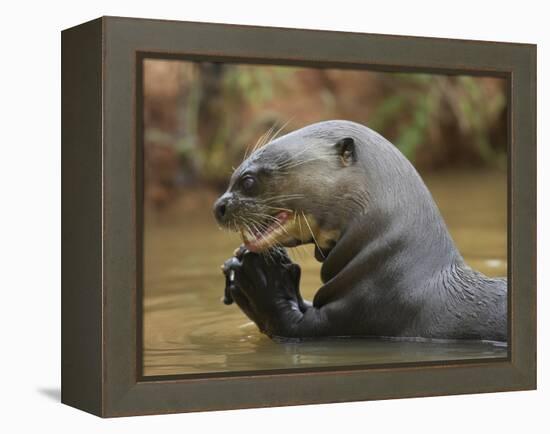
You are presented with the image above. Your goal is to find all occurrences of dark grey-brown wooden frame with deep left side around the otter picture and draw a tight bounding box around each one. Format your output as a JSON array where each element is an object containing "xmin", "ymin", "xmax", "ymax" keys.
[{"xmin": 62, "ymin": 17, "xmax": 536, "ymax": 417}]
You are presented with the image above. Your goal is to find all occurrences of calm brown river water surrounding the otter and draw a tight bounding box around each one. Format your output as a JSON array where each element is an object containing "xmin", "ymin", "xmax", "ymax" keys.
[{"xmin": 143, "ymin": 171, "xmax": 507, "ymax": 375}]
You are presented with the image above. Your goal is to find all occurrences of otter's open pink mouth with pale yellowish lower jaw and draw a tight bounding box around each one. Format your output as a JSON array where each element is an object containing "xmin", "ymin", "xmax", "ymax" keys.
[{"xmin": 241, "ymin": 211, "xmax": 294, "ymax": 252}]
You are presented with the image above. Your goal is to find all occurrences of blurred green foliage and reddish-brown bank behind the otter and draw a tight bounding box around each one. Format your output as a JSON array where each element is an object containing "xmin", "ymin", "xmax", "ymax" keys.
[{"xmin": 143, "ymin": 59, "xmax": 507, "ymax": 207}]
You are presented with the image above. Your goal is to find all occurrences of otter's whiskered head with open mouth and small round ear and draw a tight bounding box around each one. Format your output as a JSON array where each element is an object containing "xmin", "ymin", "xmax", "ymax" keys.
[{"xmin": 214, "ymin": 130, "xmax": 363, "ymax": 260}]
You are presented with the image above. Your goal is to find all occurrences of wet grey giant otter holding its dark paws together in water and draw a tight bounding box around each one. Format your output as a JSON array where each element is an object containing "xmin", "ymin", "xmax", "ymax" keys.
[{"xmin": 214, "ymin": 121, "xmax": 507, "ymax": 341}]
